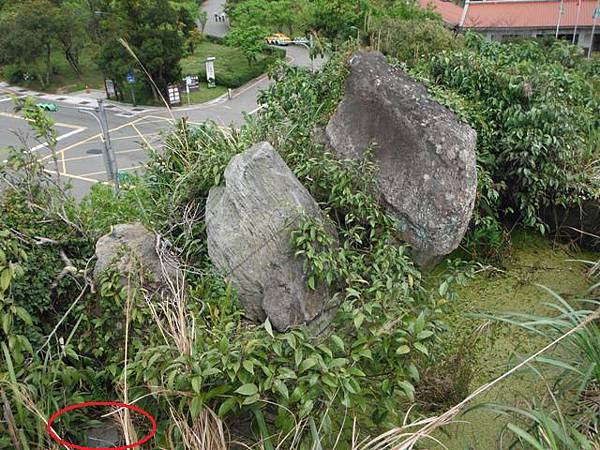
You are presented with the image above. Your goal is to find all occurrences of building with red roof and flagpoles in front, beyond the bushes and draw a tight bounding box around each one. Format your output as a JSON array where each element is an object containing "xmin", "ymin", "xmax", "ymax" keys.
[{"xmin": 419, "ymin": 0, "xmax": 600, "ymax": 50}]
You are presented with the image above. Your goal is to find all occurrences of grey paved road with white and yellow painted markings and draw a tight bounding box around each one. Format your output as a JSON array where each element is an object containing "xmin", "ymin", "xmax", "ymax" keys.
[{"xmin": 0, "ymin": 0, "xmax": 322, "ymax": 198}]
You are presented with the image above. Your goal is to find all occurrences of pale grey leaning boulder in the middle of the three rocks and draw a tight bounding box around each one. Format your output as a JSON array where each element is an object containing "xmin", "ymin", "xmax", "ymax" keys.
[{"xmin": 206, "ymin": 142, "xmax": 338, "ymax": 331}]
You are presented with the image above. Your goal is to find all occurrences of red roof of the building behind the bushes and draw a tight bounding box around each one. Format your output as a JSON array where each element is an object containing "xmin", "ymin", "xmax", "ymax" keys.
[{"xmin": 419, "ymin": 0, "xmax": 600, "ymax": 28}]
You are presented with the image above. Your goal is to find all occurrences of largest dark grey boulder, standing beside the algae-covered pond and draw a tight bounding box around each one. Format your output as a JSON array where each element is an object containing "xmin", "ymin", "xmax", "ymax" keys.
[{"xmin": 326, "ymin": 52, "xmax": 477, "ymax": 265}]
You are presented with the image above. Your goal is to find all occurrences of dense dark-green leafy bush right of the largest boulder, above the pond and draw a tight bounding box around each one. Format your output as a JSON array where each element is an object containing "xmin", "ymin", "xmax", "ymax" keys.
[{"xmin": 413, "ymin": 35, "xmax": 600, "ymax": 243}]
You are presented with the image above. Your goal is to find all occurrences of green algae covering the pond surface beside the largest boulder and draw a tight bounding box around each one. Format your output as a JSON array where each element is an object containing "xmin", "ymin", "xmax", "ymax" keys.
[{"xmin": 428, "ymin": 231, "xmax": 600, "ymax": 450}]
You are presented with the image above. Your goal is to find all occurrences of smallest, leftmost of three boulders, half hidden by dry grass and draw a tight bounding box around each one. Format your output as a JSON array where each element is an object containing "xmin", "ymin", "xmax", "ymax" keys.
[{"xmin": 94, "ymin": 223, "xmax": 183, "ymax": 287}]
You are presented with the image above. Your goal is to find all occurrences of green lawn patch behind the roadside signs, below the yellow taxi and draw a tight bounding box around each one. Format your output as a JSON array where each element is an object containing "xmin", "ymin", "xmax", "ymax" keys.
[{"xmin": 181, "ymin": 40, "xmax": 275, "ymax": 88}]
